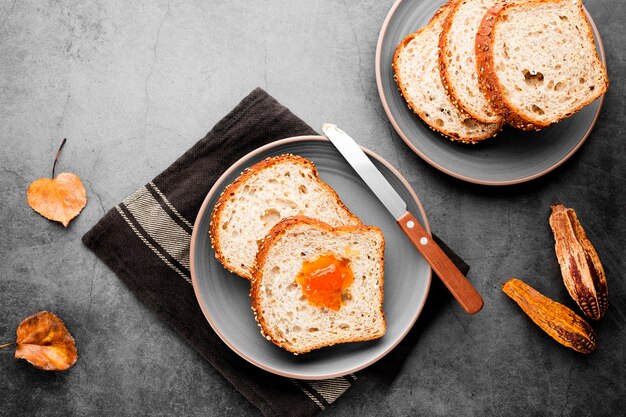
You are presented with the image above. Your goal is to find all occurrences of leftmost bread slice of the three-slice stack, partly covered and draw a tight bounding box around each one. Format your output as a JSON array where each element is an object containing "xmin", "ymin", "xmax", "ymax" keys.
[{"xmin": 393, "ymin": 3, "xmax": 502, "ymax": 143}]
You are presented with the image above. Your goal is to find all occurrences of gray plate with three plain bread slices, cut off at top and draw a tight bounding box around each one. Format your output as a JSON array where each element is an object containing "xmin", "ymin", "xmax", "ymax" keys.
[{"xmin": 375, "ymin": 0, "xmax": 608, "ymax": 185}]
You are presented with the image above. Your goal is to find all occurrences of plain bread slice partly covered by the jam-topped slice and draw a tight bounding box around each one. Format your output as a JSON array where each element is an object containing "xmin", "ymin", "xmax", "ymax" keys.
[{"xmin": 210, "ymin": 155, "xmax": 361, "ymax": 279}]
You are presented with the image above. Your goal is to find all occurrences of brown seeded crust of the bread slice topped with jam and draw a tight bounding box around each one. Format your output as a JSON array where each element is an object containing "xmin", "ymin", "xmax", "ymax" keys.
[{"xmin": 250, "ymin": 216, "xmax": 387, "ymax": 354}]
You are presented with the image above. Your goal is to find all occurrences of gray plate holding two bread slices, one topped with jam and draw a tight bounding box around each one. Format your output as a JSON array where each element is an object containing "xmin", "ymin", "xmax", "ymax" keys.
[{"xmin": 190, "ymin": 136, "xmax": 431, "ymax": 379}]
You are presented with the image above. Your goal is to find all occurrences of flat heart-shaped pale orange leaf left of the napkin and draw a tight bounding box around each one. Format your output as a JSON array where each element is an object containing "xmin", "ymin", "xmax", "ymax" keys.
[{"xmin": 26, "ymin": 172, "xmax": 87, "ymax": 227}]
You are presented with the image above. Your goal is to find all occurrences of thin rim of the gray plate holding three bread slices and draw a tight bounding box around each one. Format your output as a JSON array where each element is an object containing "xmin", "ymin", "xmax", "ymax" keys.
[{"xmin": 374, "ymin": 0, "xmax": 606, "ymax": 186}]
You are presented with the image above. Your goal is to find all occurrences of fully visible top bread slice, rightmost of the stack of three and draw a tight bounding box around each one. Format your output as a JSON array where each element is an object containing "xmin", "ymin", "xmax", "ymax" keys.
[{"xmin": 476, "ymin": 0, "xmax": 608, "ymax": 130}]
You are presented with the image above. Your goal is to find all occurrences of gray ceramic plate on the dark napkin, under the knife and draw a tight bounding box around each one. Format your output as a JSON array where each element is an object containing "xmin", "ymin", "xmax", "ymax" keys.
[{"xmin": 191, "ymin": 136, "xmax": 431, "ymax": 379}]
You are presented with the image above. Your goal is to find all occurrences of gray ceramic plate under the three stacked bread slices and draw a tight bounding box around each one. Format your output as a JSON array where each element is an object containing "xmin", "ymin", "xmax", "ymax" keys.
[{"xmin": 376, "ymin": 0, "xmax": 606, "ymax": 185}]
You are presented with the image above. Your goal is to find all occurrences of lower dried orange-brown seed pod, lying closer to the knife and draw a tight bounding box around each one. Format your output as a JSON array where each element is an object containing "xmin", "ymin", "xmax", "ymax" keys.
[{"xmin": 502, "ymin": 278, "xmax": 597, "ymax": 354}]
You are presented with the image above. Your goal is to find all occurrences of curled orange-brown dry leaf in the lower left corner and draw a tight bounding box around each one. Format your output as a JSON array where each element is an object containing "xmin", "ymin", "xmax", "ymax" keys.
[{"xmin": 15, "ymin": 311, "xmax": 78, "ymax": 371}]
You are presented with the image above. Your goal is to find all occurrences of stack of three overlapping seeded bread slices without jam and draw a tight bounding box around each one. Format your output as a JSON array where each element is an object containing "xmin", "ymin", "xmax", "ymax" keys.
[{"xmin": 393, "ymin": 0, "xmax": 608, "ymax": 143}]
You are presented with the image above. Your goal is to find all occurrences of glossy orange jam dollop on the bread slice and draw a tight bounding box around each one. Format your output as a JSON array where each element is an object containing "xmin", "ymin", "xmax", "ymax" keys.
[{"xmin": 296, "ymin": 252, "xmax": 354, "ymax": 311}]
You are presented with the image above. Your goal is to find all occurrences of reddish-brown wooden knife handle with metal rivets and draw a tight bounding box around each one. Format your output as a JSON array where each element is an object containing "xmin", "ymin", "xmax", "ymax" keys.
[{"xmin": 397, "ymin": 211, "xmax": 484, "ymax": 314}]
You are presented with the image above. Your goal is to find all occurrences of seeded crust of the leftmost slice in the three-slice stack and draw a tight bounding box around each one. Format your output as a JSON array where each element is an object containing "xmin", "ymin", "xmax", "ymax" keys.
[{"xmin": 391, "ymin": 0, "xmax": 502, "ymax": 144}]
